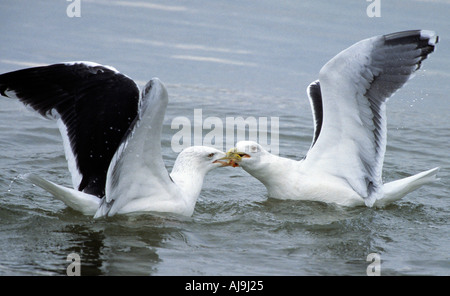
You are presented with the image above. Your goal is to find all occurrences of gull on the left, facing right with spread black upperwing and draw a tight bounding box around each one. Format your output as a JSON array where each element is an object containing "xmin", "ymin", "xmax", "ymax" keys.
[{"xmin": 0, "ymin": 61, "xmax": 232, "ymax": 218}]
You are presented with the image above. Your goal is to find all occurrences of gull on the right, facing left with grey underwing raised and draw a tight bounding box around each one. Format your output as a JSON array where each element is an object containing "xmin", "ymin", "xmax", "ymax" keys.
[{"xmin": 224, "ymin": 30, "xmax": 439, "ymax": 207}]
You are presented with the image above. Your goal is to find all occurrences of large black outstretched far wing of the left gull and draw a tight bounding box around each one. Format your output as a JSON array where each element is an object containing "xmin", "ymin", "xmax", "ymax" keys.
[{"xmin": 0, "ymin": 62, "xmax": 139, "ymax": 197}]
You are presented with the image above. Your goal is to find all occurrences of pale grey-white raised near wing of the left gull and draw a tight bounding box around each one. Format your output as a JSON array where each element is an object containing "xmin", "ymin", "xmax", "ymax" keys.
[{"xmin": 95, "ymin": 78, "xmax": 177, "ymax": 217}]
